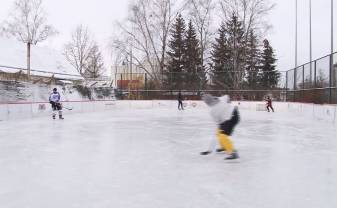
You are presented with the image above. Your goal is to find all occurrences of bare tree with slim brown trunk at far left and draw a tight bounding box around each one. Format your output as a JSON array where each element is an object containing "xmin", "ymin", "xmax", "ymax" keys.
[{"xmin": 4, "ymin": 0, "xmax": 57, "ymax": 78}]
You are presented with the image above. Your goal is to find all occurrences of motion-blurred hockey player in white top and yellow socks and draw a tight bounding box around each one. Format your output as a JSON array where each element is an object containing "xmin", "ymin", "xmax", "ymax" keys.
[{"xmin": 200, "ymin": 94, "xmax": 240, "ymax": 160}]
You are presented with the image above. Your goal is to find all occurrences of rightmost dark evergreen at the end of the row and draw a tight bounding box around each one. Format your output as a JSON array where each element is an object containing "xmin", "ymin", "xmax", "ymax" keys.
[{"xmin": 260, "ymin": 39, "xmax": 280, "ymax": 89}]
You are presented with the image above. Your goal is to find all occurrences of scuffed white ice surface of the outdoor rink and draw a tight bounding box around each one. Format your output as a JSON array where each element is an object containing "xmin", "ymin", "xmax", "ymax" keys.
[{"xmin": 0, "ymin": 105, "xmax": 337, "ymax": 208}]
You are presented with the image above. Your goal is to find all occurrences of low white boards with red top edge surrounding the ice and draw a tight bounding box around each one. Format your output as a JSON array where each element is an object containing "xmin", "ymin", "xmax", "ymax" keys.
[{"xmin": 0, "ymin": 100, "xmax": 337, "ymax": 124}]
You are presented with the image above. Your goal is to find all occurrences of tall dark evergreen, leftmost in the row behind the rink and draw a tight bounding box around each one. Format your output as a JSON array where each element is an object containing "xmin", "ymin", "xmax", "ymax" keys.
[{"xmin": 164, "ymin": 14, "xmax": 186, "ymax": 89}]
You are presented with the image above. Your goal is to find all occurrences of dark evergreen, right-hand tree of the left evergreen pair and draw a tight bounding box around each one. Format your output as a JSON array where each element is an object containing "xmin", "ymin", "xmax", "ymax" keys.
[{"xmin": 183, "ymin": 21, "xmax": 206, "ymax": 89}]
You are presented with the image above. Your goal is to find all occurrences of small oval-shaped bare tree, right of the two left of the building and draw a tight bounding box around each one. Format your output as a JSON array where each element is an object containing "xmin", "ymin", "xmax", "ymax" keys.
[{"xmin": 84, "ymin": 44, "xmax": 104, "ymax": 79}]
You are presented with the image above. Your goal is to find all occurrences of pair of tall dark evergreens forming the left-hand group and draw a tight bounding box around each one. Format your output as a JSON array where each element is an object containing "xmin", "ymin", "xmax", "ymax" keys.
[{"xmin": 163, "ymin": 15, "xmax": 207, "ymax": 89}]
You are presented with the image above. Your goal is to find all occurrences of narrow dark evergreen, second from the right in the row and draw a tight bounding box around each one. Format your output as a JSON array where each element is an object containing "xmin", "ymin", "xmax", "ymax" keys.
[{"xmin": 246, "ymin": 31, "xmax": 261, "ymax": 89}]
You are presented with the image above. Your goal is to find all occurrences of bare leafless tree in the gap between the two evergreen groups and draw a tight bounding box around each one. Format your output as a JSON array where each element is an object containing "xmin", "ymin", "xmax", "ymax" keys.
[{"xmin": 185, "ymin": 0, "xmax": 216, "ymax": 66}]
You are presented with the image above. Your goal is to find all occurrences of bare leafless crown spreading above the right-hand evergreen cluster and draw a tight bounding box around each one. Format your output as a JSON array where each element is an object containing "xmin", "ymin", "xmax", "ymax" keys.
[{"xmin": 219, "ymin": 0, "xmax": 275, "ymax": 39}]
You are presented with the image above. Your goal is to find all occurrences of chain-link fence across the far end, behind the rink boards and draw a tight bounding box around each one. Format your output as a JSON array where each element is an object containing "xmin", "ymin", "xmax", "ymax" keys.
[{"xmin": 115, "ymin": 72, "xmax": 286, "ymax": 101}]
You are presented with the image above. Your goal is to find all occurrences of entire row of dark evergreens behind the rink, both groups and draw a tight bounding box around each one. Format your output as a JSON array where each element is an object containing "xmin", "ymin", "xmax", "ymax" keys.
[{"xmin": 163, "ymin": 15, "xmax": 280, "ymax": 90}]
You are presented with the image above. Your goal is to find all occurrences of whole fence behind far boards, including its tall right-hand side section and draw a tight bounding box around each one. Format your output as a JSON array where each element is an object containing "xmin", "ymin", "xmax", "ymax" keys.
[{"xmin": 115, "ymin": 52, "xmax": 337, "ymax": 104}]
